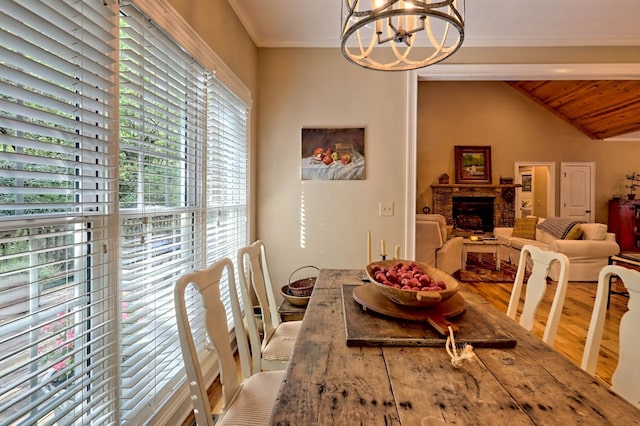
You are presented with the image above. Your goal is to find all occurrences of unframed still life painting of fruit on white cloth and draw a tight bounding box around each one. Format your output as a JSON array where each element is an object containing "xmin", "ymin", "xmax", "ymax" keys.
[{"xmin": 301, "ymin": 127, "xmax": 365, "ymax": 180}]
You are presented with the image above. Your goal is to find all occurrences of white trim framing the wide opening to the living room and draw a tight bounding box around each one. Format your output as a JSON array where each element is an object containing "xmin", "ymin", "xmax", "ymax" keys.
[{"xmin": 404, "ymin": 63, "xmax": 640, "ymax": 259}]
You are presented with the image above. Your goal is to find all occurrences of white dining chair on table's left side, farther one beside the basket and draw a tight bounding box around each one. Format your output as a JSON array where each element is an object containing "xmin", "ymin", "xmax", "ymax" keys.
[{"xmin": 238, "ymin": 240, "xmax": 302, "ymax": 372}]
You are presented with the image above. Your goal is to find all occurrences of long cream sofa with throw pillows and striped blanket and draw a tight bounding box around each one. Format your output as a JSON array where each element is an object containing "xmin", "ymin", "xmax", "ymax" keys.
[{"xmin": 494, "ymin": 218, "xmax": 620, "ymax": 281}]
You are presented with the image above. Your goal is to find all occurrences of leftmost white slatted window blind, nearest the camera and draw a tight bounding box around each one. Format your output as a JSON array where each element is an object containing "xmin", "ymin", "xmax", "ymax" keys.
[{"xmin": 0, "ymin": 0, "xmax": 118, "ymax": 425}]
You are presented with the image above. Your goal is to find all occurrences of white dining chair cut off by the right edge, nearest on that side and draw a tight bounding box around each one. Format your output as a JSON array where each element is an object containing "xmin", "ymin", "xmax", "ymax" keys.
[{"xmin": 580, "ymin": 265, "xmax": 640, "ymax": 408}]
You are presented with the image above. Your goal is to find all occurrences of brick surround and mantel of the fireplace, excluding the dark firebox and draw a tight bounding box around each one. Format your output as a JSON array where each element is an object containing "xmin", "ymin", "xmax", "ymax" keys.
[{"xmin": 431, "ymin": 183, "xmax": 522, "ymax": 227}]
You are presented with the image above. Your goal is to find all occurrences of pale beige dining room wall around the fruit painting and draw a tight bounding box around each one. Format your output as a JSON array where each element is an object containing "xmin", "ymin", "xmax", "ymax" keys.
[{"xmin": 254, "ymin": 49, "xmax": 414, "ymax": 288}]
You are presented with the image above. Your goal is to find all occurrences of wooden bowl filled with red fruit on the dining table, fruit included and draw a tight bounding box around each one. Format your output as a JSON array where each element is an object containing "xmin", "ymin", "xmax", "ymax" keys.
[{"xmin": 366, "ymin": 260, "xmax": 460, "ymax": 307}]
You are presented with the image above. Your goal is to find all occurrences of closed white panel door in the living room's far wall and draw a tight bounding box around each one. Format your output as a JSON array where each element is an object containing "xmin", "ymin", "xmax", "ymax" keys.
[{"xmin": 560, "ymin": 163, "xmax": 596, "ymax": 222}]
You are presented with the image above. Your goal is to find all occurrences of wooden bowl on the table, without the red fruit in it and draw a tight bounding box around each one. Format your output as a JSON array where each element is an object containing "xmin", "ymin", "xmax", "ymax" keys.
[{"xmin": 366, "ymin": 259, "xmax": 460, "ymax": 307}]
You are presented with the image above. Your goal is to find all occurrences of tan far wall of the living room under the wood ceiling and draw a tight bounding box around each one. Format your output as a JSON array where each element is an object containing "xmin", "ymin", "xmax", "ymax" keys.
[{"xmin": 417, "ymin": 81, "xmax": 640, "ymax": 223}]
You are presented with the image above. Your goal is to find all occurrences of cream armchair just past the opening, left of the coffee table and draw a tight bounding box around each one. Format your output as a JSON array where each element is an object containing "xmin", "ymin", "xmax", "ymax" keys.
[{"xmin": 415, "ymin": 214, "xmax": 463, "ymax": 275}]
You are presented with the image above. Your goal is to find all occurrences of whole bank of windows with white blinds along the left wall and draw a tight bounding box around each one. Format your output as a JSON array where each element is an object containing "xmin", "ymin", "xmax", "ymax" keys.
[{"xmin": 0, "ymin": 0, "xmax": 248, "ymax": 424}]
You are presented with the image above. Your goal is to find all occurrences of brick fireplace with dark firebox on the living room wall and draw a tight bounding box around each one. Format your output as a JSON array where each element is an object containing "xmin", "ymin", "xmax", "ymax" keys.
[{"xmin": 431, "ymin": 184, "xmax": 516, "ymax": 232}]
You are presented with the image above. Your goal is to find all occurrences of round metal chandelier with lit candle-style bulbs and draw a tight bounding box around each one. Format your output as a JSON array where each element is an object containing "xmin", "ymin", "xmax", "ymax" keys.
[{"xmin": 341, "ymin": 0, "xmax": 464, "ymax": 71}]
